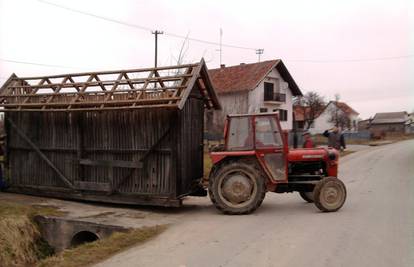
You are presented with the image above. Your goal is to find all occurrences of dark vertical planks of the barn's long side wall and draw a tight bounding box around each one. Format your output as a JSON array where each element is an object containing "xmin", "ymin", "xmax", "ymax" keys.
[{"xmin": 6, "ymin": 109, "xmax": 177, "ymax": 197}]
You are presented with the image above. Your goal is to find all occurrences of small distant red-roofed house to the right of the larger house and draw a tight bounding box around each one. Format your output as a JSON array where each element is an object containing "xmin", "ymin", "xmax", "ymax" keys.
[{"xmin": 295, "ymin": 101, "xmax": 359, "ymax": 134}]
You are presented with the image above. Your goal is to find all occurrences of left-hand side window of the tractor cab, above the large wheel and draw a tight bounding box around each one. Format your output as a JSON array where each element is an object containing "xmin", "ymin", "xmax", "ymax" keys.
[{"xmin": 227, "ymin": 117, "xmax": 253, "ymax": 151}]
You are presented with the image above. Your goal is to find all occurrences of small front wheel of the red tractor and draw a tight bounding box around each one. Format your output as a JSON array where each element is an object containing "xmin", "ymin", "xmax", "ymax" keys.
[{"xmin": 313, "ymin": 177, "xmax": 346, "ymax": 212}]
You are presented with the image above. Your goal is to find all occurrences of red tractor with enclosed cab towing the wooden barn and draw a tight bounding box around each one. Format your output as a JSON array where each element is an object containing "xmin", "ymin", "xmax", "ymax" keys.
[{"xmin": 209, "ymin": 113, "xmax": 346, "ymax": 214}]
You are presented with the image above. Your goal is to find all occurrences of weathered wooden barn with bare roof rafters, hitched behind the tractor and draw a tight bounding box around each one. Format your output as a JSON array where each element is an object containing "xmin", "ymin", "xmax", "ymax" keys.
[{"xmin": 0, "ymin": 61, "xmax": 220, "ymax": 206}]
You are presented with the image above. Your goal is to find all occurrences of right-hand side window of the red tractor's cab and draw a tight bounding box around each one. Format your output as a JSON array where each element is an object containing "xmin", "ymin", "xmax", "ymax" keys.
[{"xmin": 256, "ymin": 117, "xmax": 282, "ymax": 148}]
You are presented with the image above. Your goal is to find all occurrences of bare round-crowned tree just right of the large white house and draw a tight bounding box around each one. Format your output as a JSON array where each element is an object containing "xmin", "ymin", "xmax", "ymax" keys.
[{"xmin": 294, "ymin": 91, "xmax": 326, "ymax": 129}]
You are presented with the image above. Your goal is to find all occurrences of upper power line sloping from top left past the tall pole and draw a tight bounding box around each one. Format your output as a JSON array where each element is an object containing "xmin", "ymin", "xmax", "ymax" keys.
[{"xmin": 38, "ymin": 0, "xmax": 256, "ymax": 51}]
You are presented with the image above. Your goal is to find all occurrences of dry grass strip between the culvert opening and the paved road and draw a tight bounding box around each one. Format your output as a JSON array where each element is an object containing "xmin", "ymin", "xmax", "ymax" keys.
[{"xmin": 37, "ymin": 225, "xmax": 166, "ymax": 267}]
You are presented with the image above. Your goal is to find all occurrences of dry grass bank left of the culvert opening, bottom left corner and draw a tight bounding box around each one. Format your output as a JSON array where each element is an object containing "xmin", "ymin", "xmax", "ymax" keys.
[{"xmin": 0, "ymin": 201, "xmax": 62, "ymax": 267}]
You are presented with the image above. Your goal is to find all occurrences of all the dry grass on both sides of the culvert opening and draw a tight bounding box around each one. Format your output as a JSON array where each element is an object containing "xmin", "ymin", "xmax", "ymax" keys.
[{"xmin": 0, "ymin": 201, "xmax": 166, "ymax": 267}]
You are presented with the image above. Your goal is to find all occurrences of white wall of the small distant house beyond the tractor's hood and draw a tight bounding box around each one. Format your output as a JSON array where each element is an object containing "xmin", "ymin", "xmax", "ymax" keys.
[{"xmin": 309, "ymin": 103, "xmax": 358, "ymax": 134}]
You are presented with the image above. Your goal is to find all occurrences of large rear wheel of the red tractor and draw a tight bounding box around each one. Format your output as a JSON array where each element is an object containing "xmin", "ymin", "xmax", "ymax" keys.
[{"xmin": 209, "ymin": 160, "xmax": 266, "ymax": 214}]
